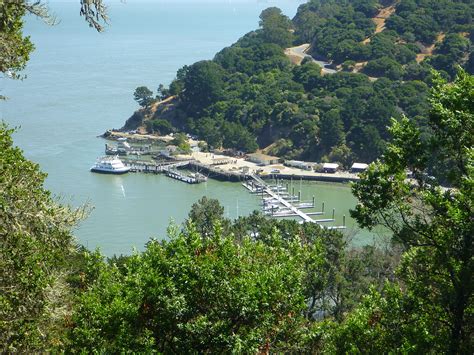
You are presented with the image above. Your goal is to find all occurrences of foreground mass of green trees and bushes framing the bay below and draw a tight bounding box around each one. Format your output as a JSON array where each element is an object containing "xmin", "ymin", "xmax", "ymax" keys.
[{"xmin": 0, "ymin": 71, "xmax": 474, "ymax": 354}]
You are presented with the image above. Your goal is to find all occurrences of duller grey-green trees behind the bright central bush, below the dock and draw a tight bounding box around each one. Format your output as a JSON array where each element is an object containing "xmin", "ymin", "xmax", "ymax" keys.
[{"xmin": 232, "ymin": 212, "xmax": 399, "ymax": 321}]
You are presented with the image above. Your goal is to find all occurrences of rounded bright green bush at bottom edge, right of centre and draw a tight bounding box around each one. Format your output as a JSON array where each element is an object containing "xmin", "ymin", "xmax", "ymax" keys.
[{"xmin": 318, "ymin": 284, "xmax": 436, "ymax": 354}]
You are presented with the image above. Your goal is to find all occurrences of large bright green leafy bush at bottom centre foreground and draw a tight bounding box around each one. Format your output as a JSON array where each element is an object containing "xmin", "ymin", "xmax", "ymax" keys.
[{"xmin": 66, "ymin": 224, "xmax": 307, "ymax": 353}]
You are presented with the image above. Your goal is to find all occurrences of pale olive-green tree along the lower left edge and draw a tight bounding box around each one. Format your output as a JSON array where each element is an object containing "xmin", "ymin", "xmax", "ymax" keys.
[{"xmin": 0, "ymin": 123, "xmax": 84, "ymax": 353}]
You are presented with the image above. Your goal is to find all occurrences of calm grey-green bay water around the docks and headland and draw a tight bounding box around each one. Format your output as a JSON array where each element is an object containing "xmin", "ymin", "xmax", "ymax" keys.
[{"xmin": 0, "ymin": 0, "xmax": 374, "ymax": 255}]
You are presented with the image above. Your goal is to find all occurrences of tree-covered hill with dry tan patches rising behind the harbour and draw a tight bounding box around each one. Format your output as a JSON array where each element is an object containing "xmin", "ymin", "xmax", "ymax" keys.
[{"xmin": 126, "ymin": 0, "xmax": 474, "ymax": 165}]
